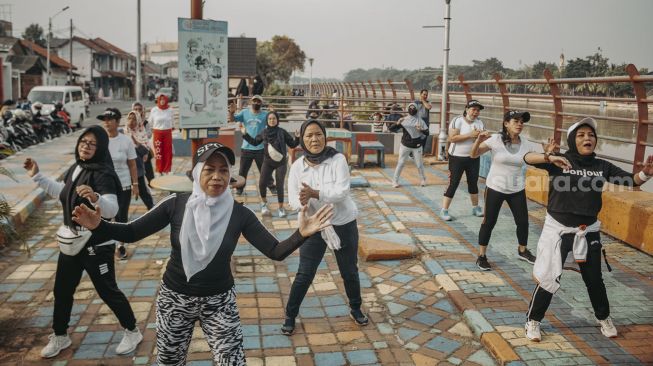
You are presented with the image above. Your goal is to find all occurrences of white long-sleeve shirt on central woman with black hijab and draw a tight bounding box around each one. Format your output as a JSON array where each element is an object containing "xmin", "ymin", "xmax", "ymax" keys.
[{"xmin": 288, "ymin": 154, "xmax": 358, "ymax": 225}]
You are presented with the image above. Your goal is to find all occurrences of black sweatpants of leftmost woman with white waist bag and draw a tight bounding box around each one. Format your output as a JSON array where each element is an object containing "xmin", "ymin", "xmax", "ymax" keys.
[{"xmin": 52, "ymin": 244, "xmax": 136, "ymax": 335}]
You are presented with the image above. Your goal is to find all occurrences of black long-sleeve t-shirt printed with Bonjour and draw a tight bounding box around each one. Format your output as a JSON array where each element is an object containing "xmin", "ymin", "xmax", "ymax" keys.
[{"xmin": 532, "ymin": 158, "xmax": 634, "ymax": 227}]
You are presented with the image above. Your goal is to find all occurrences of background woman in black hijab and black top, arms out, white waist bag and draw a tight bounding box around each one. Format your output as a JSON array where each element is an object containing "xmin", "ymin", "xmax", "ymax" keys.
[{"xmin": 240, "ymin": 112, "xmax": 299, "ymax": 217}]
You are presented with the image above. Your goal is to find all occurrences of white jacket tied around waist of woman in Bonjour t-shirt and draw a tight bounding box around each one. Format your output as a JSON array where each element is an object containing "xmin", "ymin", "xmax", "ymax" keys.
[{"xmin": 533, "ymin": 214, "xmax": 601, "ymax": 294}]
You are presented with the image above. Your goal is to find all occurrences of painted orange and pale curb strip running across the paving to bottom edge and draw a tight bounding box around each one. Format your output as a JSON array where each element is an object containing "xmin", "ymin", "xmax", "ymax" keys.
[{"xmin": 427, "ymin": 274, "xmax": 522, "ymax": 365}]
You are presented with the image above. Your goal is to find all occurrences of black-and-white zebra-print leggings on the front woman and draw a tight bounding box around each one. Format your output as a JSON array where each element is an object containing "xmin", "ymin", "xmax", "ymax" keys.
[{"xmin": 156, "ymin": 282, "xmax": 245, "ymax": 366}]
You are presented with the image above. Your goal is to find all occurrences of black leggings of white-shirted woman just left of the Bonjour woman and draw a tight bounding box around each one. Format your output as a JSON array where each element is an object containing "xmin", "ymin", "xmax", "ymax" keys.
[{"xmin": 478, "ymin": 187, "xmax": 528, "ymax": 246}]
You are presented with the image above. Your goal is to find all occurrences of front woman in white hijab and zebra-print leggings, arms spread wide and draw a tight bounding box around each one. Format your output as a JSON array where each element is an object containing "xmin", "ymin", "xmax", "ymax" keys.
[{"xmin": 73, "ymin": 143, "xmax": 332, "ymax": 365}]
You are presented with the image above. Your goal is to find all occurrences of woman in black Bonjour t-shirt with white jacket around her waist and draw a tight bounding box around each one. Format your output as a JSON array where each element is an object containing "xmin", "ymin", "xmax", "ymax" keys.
[{"xmin": 524, "ymin": 118, "xmax": 653, "ymax": 342}]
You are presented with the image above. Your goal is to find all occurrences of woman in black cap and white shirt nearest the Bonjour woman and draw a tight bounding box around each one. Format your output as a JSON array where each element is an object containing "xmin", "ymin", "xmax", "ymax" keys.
[{"xmin": 470, "ymin": 111, "xmax": 541, "ymax": 271}]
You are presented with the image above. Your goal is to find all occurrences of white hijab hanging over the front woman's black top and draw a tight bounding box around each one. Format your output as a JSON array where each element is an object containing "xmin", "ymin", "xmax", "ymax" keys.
[{"xmin": 179, "ymin": 157, "xmax": 234, "ymax": 281}]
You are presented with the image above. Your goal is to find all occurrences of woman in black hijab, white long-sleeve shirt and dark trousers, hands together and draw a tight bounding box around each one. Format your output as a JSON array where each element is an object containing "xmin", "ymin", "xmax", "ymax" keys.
[{"xmin": 281, "ymin": 120, "xmax": 368, "ymax": 335}]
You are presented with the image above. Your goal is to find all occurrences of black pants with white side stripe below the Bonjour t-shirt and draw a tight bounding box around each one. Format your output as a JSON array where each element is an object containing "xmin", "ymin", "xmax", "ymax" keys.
[{"xmin": 527, "ymin": 232, "xmax": 610, "ymax": 322}]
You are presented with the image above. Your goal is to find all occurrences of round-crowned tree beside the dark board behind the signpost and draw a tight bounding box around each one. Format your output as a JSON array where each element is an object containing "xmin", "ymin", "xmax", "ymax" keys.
[{"xmin": 256, "ymin": 36, "xmax": 306, "ymax": 85}]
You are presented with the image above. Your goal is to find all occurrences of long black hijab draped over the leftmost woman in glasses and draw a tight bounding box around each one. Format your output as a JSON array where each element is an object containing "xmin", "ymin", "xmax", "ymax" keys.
[{"xmin": 59, "ymin": 125, "xmax": 121, "ymax": 226}]
